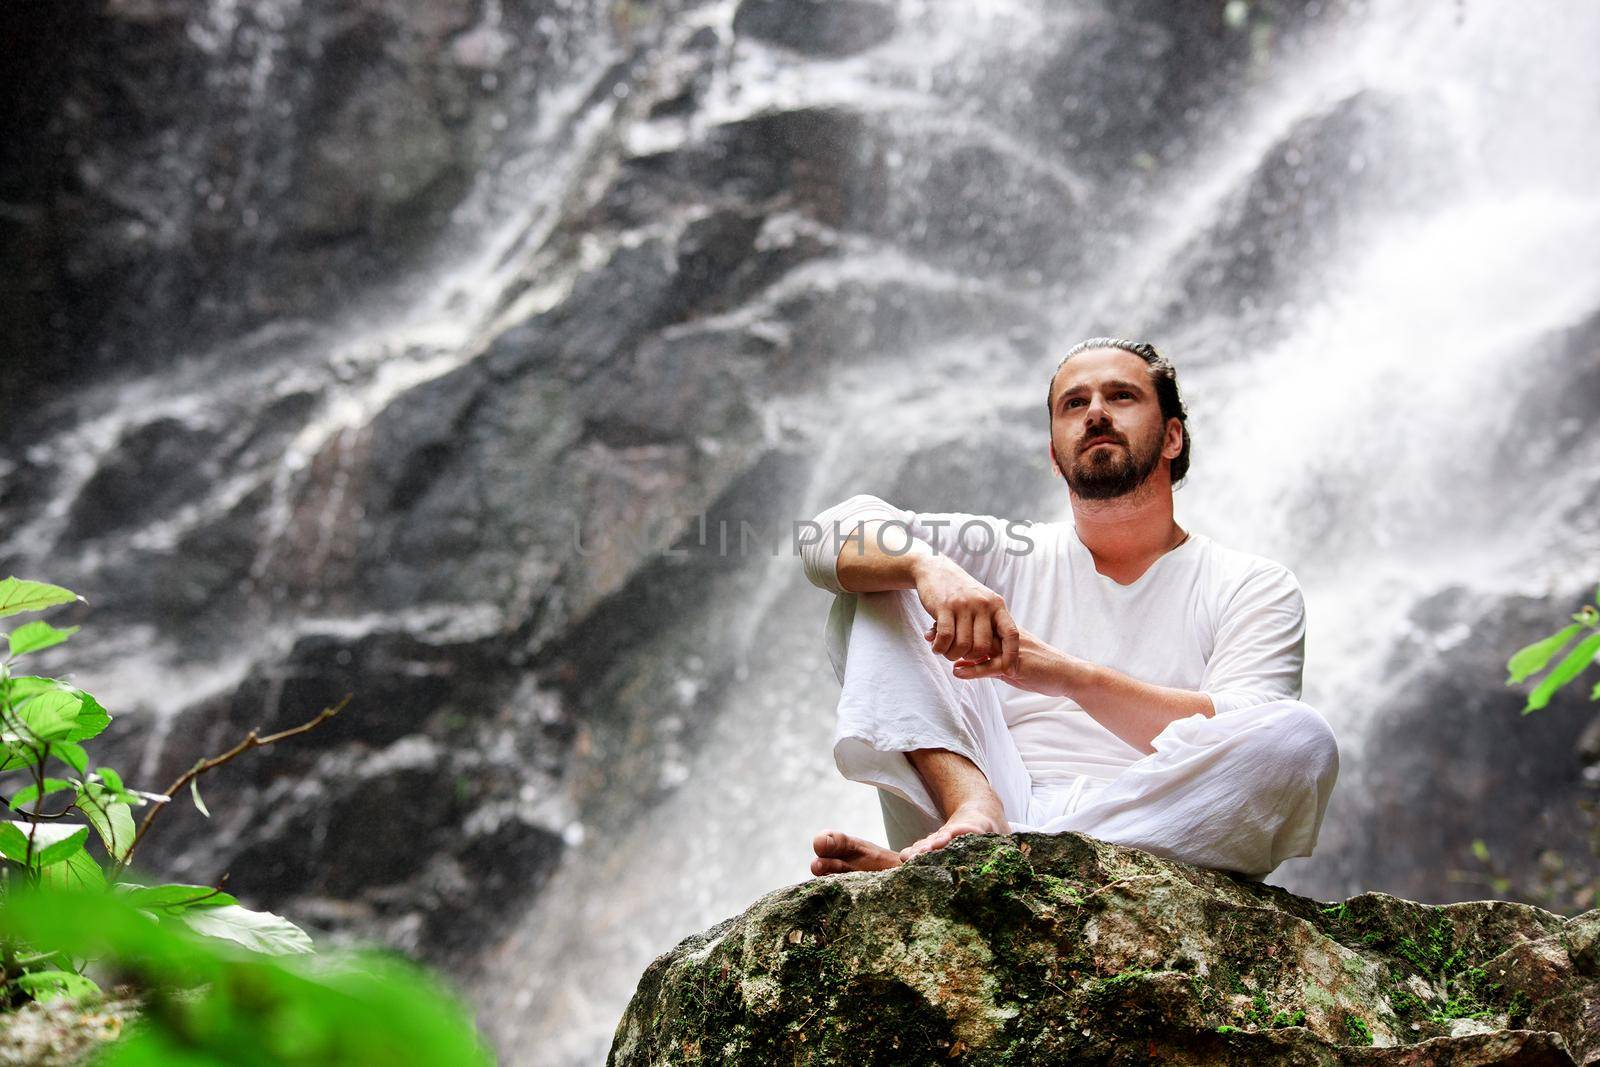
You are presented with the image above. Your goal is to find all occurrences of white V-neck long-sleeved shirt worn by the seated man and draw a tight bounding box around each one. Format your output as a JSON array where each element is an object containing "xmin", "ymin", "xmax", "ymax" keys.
[{"xmin": 802, "ymin": 494, "xmax": 1306, "ymax": 784}]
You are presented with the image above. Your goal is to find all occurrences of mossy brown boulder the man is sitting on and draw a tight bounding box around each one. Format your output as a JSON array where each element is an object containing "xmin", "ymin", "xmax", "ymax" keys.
[{"xmin": 608, "ymin": 833, "xmax": 1600, "ymax": 1067}]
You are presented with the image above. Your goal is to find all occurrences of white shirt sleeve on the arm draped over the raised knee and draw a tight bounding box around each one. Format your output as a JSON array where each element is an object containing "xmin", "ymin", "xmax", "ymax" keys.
[{"xmin": 797, "ymin": 493, "xmax": 1026, "ymax": 593}]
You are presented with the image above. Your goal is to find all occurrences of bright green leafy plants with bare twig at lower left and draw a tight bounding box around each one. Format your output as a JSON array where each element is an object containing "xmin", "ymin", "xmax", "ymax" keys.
[{"xmin": 0, "ymin": 577, "xmax": 491, "ymax": 1067}]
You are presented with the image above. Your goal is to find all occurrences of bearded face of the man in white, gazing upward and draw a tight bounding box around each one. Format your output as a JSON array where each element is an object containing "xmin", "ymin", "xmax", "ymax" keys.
[{"xmin": 1050, "ymin": 349, "xmax": 1176, "ymax": 501}]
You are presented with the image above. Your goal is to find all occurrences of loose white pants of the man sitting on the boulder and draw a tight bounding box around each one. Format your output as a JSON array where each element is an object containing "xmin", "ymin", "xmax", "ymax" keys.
[{"xmin": 834, "ymin": 589, "xmax": 1339, "ymax": 878}]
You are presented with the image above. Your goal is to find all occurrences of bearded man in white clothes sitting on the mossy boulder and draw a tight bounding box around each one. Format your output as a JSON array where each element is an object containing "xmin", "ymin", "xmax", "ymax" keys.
[{"xmin": 802, "ymin": 338, "xmax": 1339, "ymax": 878}]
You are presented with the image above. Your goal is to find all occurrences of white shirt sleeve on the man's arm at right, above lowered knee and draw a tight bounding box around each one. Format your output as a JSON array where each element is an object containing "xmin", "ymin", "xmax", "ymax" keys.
[{"xmin": 1200, "ymin": 566, "xmax": 1306, "ymax": 715}]
